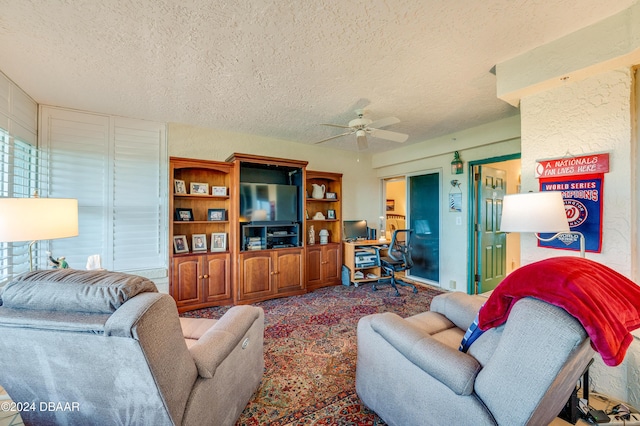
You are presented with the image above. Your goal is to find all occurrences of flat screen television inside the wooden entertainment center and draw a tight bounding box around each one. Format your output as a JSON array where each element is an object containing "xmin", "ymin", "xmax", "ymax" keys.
[{"xmin": 240, "ymin": 182, "xmax": 299, "ymax": 222}]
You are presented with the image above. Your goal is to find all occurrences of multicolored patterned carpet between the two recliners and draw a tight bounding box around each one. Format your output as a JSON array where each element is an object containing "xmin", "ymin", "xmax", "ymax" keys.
[{"xmin": 183, "ymin": 286, "xmax": 441, "ymax": 426}]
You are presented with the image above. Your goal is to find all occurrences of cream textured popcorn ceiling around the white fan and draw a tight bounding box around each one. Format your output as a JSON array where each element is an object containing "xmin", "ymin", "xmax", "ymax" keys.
[{"xmin": 0, "ymin": 0, "xmax": 637, "ymax": 152}]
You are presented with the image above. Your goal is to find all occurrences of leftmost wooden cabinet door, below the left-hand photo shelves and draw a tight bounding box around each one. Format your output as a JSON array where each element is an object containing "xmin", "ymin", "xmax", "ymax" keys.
[{"xmin": 171, "ymin": 256, "xmax": 203, "ymax": 307}]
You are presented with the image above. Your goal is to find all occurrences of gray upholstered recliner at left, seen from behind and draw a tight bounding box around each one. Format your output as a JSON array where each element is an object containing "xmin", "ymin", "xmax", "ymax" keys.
[{"xmin": 0, "ymin": 269, "xmax": 264, "ymax": 425}]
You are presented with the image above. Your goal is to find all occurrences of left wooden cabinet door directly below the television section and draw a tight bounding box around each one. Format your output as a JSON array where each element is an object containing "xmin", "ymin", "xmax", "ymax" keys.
[{"xmin": 238, "ymin": 251, "xmax": 275, "ymax": 300}]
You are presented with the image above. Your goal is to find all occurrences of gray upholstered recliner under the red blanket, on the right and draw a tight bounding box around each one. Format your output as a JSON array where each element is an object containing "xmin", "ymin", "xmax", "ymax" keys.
[{"xmin": 356, "ymin": 293, "xmax": 594, "ymax": 426}]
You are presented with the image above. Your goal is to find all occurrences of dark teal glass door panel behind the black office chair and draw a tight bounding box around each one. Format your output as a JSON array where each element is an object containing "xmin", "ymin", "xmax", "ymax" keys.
[{"xmin": 407, "ymin": 171, "xmax": 442, "ymax": 285}]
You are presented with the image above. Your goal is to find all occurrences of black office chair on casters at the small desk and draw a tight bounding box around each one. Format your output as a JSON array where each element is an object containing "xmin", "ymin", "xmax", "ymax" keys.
[{"xmin": 373, "ymin": 229, "xmax": 418, "ymax": 296}]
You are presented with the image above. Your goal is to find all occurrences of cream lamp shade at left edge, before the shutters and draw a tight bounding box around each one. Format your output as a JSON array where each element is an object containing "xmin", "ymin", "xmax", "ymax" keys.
[{"xmin": 0, "ymin": 198, "xmax": 78, "ymax": 243}]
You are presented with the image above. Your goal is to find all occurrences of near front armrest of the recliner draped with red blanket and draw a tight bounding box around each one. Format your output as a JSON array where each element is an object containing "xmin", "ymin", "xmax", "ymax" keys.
[{"xmin": 371, "ymin": 312, "xmax": 480, "ymax": 395}]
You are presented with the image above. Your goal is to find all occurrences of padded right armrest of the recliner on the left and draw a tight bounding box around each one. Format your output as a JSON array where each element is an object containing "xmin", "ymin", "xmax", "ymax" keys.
[{"xmin": 189, "ymin": 305, "xmax": 262, "ymax": 379}]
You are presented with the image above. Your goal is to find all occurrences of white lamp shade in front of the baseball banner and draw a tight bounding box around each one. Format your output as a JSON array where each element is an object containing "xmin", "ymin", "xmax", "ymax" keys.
[{"xmin": 500, "ymin": 191, "xmax": 570, "ymax": 233}]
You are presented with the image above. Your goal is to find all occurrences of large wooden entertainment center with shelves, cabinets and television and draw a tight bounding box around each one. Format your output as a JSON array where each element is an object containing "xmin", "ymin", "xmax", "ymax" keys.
[{"xmin": 169, "ymin": 153, "xmax": 342, "ymax": 312}]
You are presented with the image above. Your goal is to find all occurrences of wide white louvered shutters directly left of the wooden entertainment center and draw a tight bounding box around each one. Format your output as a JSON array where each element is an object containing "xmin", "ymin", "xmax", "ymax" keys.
[{"xmin": 41, "ymin": 107, "xmax": 168, "ymax": 271}]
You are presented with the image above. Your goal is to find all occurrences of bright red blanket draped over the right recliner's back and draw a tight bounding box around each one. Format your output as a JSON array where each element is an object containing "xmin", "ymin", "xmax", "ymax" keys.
[{"xmin": 478, "ymin": 257, "xmax": 640, "ymax": 366}]
